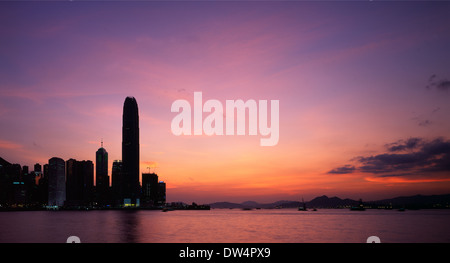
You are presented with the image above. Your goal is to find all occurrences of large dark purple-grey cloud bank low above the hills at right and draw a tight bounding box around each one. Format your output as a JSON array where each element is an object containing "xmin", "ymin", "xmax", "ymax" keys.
[{"xmin": 328, "ymin": 138, "xmax": 450, "ymax": 181}]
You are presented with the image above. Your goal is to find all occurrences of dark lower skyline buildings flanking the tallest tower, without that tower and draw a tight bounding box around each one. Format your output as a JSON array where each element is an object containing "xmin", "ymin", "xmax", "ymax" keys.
[{"xmin": 0, "ymin": 157, "xmax": 166, "ymax": 209}]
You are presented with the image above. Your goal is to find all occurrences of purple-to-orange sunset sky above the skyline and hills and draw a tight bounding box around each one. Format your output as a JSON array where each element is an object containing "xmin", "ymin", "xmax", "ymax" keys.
[{"xmin": 0, "ymin": 1, "xmax": 450, "ymax": 203}]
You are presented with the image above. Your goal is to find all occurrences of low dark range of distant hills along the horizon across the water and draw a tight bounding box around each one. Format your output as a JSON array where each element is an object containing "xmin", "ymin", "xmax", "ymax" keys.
[{"xmin": 209, "ymin": 194, "xmax": 450, "ymax": 208}]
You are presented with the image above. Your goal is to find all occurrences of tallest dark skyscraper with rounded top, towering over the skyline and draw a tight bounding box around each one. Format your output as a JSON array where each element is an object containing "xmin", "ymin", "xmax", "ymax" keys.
[{"xmin": 121, "ymin": 97, "xmax": 140, "ymax": 206}]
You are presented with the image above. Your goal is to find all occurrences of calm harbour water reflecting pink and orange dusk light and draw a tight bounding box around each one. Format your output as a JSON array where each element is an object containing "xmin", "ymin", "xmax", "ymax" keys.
[{"xmin": 0, "ymin": 209, "xmax": 450, "ymax": 243}]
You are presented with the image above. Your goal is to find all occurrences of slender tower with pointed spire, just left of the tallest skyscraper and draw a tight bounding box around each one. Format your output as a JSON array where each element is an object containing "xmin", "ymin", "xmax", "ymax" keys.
[{"xmin": 95, "ymin": 140, "xmax": 109, "ymax": 202}]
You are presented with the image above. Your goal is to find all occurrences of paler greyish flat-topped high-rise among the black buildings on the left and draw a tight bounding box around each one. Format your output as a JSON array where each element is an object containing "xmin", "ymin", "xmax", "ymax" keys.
[{"xmin": 48, "ymin": 157, "xmax": 66, "ymax": 206}]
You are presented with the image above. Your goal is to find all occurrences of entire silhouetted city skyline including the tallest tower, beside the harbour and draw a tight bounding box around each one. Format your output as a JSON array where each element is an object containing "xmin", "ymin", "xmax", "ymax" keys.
[{"xmin": 0, "ymin": 97, "xmax": 166, "ymax": 209}]
